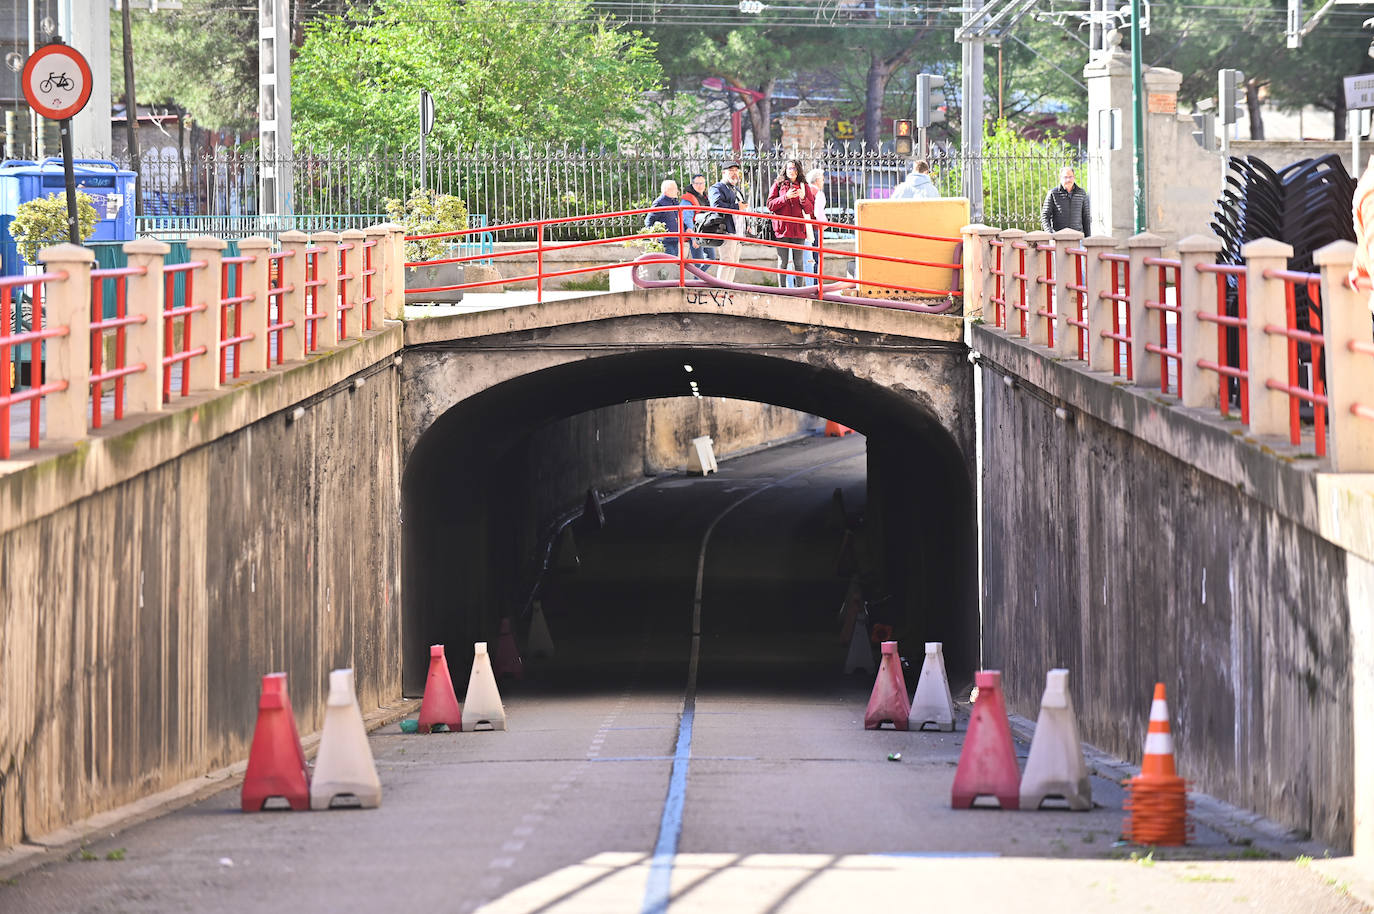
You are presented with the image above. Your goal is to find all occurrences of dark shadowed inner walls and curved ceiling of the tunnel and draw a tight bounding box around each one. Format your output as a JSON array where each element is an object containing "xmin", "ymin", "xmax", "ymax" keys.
[{"xmin": 401, "ymin": 348, "xmax": 980, "ymax": 694}]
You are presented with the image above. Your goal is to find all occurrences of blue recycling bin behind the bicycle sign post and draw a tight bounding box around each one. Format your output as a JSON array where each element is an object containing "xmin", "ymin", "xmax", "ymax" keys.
[{"xmin": 0, "ymin": 158, "xmax": 136, "ymax": 276}]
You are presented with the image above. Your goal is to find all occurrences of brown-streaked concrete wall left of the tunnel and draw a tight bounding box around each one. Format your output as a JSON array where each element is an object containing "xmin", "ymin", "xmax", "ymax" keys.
[{"xmin": 0, "ymin": 324, "xmax": 401, "ymax": 847}]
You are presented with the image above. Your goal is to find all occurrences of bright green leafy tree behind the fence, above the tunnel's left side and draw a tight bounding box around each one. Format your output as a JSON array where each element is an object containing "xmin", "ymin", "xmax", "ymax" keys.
[{"xmin": 291, "ymin": 0, "xmax": 662, "ymax": 148}]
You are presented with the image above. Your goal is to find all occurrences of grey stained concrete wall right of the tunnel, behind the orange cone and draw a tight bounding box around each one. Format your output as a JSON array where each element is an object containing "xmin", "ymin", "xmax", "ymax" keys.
[{"xmin": 973, "ymin": 327, "xmax": 1369, "ymax": 848}]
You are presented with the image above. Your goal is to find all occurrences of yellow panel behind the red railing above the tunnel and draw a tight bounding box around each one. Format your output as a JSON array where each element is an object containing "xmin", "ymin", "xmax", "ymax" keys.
[{"xmin": 855, "ymin": 197, "xmax": 969, "ymax": 300}]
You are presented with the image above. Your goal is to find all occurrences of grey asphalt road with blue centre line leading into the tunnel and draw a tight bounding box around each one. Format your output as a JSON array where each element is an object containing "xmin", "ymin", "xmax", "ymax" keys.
[{"xmin": 0, "ymin": 436, "xmax": 1369, "ymax": 914}]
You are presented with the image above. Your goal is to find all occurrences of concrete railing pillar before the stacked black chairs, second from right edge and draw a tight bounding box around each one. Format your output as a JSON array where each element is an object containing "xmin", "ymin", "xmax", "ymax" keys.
[{"xmin": 1241, "ymin": 238, "xmax": 1293, "ymax": 436}]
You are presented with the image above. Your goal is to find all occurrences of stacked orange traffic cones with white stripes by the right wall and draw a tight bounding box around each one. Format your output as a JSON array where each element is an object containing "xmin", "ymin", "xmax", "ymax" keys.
[{"xmin": 1125, "ymin": 682, "xmax": 1191, "ymax": 847}]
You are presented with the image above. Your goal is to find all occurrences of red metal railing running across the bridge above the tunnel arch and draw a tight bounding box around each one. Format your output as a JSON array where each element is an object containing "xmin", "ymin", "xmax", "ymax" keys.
[{"xmin": 405, "ymin": 206, "xmax": 963, "ymax": 311}]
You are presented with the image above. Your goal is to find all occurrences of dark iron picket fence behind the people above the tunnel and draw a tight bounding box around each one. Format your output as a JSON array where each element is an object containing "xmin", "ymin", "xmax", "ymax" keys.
[{"xmin": 112, "ymin": 146, "xmax": 1092, "ymax": 241}]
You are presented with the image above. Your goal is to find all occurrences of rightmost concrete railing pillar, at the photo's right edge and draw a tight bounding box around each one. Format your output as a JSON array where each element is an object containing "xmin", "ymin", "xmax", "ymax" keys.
[{"xmin": 1312, "ymin": 241, "xmax": 1374, "ymax": 473}]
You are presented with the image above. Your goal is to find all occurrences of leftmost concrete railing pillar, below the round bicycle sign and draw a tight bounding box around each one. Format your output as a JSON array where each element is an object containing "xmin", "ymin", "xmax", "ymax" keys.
[{"xmin": 33, "ymin": 245, "xmax": 95, "ymax": 441}]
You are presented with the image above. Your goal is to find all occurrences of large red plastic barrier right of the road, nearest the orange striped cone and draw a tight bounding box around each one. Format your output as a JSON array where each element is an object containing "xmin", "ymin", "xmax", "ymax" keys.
[{"xmin": 949, "ymin": 669, "xmax": 1021, "ymax": 810}]
